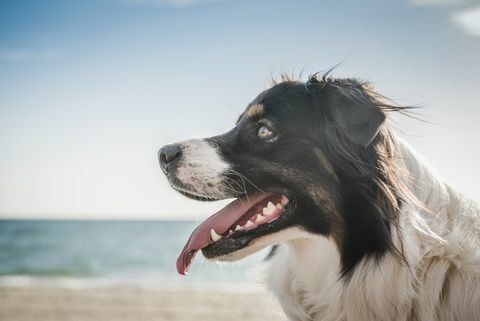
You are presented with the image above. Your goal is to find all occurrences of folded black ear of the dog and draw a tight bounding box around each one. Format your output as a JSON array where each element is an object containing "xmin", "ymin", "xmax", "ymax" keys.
[{"xmin": 328, "ymin": 86, "xmax": 385, "ymax": 147}]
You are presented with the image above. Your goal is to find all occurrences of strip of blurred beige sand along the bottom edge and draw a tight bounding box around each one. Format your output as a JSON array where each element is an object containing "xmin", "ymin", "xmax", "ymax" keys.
[{"xmin": 0, "ymin": 286, "xmax": 285, "ymax": 321}]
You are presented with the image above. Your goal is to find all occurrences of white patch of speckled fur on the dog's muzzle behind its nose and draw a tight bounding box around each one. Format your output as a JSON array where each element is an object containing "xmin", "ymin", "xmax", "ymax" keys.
[{"xmin": 174, "ymin": 139, "xmax": 229, "ymax": 198}]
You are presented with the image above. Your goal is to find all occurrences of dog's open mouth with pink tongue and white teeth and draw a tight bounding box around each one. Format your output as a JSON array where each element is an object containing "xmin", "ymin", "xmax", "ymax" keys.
[{"xmin": 177, "ymin": 193, "xmax": 291, "ymax": 275}]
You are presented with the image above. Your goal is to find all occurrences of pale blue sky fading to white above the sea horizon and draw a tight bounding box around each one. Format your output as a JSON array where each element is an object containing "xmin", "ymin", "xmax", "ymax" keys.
[{"xmin": 0, "ymin": 0, "xmax": 480, "ymax": 219}]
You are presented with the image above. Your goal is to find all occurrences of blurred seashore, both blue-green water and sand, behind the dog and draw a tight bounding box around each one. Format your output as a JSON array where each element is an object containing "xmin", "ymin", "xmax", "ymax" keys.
[{"xmin": 0, "ymin": 221, "xmax": 285, "ymax": 321}]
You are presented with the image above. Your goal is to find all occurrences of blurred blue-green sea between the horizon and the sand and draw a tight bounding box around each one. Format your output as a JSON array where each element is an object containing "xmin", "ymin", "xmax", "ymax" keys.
[{"xmin": 0, "ymin": 220, "xmax": 266, "ymax": 290}]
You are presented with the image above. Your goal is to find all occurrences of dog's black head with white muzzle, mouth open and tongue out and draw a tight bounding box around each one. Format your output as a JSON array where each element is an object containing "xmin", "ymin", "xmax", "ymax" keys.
[{"xmin": 159, "ymin": 77, "xmax": 404, "ymax": 274}]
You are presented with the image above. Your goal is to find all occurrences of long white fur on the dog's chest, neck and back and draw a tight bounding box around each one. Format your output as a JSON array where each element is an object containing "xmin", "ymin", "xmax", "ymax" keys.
[{"xmin": 256, "ymin": 141, "xmax": 480, "ymax": 321}]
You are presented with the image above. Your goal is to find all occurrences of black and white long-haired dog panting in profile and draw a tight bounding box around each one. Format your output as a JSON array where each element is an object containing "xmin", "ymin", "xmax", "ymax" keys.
[{"xmin": 158, "ymin": 74, "xmax": 480, "ymax": 321}]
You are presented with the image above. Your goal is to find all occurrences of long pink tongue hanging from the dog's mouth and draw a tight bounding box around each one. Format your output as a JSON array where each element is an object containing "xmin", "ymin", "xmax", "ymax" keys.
[{"xmin": 177, "ymin": 193, "xmax": 273, "ymax": 275}]
